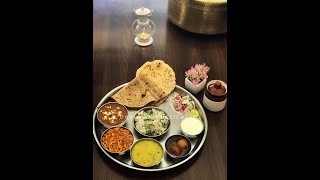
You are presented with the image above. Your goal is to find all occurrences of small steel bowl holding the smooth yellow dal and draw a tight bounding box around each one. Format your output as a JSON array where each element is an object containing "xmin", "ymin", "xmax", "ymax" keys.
[{"xmin": 130, "ymin": 138, "xmax": 164, "ymax": 168}]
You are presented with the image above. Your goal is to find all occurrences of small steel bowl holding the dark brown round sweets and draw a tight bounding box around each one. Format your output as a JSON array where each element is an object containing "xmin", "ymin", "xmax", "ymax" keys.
[{"xmin": 165, "ymin": 134, "xmax": 191, "ymax": 159}]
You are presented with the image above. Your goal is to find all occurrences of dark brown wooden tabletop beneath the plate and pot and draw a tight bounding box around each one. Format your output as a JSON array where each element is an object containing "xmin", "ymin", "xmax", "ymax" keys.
[{"xmin": 92, "ymin": 0, "xmax": 227, "ymax": 180}]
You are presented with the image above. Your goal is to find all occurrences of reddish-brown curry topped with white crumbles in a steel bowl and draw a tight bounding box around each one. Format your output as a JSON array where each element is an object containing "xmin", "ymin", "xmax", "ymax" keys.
[{"xmin": 97, "ymin": 102, "xmax": 128, "ymax": 127}]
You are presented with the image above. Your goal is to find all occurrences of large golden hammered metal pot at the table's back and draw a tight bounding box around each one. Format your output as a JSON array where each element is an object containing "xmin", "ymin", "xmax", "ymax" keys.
[{"xmin": 168, "ymin": 0, "xmax": 227, "ymax": 34}]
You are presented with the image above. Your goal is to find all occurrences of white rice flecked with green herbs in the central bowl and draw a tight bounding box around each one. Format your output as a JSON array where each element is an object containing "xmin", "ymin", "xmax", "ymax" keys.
[{"xmin": 134, "ymin": 108, "xmax": 169, "ymax": 136}]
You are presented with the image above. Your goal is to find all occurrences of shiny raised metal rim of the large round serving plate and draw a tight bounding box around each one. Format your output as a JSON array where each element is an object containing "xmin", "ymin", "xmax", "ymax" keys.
[{"xmin": 93, "ymin": 83, "xmax": 208, "ymax": 171}]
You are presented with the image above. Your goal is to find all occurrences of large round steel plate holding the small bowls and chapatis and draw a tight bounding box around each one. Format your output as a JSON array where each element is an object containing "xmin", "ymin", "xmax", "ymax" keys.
[{"xmin": 93, "ymin": 83, "xmax": 208, "ymax": 171}]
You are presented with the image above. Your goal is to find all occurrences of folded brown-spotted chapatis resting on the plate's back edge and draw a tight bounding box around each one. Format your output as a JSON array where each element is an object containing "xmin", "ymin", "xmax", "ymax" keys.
[{"xmin": 112, "ymin": 60, "xmax": 176, "ymax": 108}]
